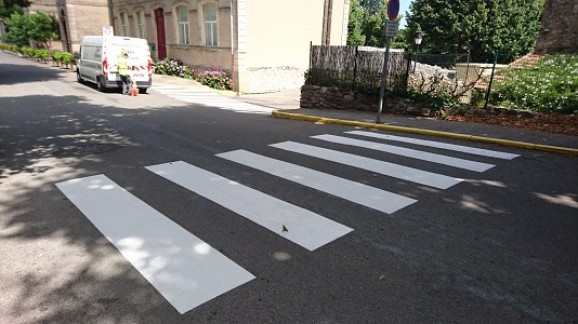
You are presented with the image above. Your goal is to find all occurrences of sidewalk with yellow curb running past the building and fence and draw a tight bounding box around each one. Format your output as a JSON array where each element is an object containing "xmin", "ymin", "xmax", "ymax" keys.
[{"xmin": 153, "ymin": 75, "xmax": 578, "ymax": 156}]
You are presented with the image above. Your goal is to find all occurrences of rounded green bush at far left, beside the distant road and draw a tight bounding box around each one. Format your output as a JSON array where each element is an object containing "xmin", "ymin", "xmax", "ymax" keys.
[{"xmin": 4, "ymin": 12, "xmax": 60, "ymax": 47}]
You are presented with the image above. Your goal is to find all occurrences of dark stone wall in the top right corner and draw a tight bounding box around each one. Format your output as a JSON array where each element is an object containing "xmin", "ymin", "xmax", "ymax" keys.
[{"xmin": 536, "ymin": 0, "xmax": 578, "ymax": 54}]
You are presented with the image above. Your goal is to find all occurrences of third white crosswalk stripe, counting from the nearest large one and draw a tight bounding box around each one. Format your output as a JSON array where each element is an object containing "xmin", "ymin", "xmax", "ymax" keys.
[{"xmin": 217, "ymin": 150, "xmax": 417, "ymax": 214}]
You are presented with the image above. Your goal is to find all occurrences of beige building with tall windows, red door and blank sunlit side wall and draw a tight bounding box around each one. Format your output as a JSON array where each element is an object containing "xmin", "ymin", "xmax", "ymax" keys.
[{"xmin": 111, "ymin": 0, "xmax": 349, "ymax": 93}]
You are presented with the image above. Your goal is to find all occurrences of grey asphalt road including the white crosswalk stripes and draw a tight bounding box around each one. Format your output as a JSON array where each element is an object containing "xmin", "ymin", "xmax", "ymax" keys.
[{"xmin": 0, "ymin": 53, "xmax": 578, "ymax": 323}]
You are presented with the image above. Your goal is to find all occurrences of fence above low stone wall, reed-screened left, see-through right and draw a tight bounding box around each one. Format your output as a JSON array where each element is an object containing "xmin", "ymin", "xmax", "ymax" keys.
[{"xmin": 306, "ymin": 45, "xmax": 503, "ymax": 107}]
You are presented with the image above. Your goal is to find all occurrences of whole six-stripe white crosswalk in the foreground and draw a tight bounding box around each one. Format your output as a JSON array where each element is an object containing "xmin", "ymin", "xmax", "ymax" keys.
[{"xmin": 56, "ymin": 131, "xmax": 518, "ymax": 314}]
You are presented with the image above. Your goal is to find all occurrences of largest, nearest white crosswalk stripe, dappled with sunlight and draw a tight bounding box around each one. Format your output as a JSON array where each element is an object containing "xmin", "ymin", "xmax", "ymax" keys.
[{"xmin": 56, "ymin": 175, "xmax": 255, "ymax": 314}]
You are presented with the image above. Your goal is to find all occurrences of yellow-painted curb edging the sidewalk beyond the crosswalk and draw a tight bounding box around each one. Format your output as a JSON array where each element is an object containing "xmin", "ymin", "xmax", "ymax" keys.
[{"xmin": 271, "ymin": 110, "xmax": 578, "ymax": 156}]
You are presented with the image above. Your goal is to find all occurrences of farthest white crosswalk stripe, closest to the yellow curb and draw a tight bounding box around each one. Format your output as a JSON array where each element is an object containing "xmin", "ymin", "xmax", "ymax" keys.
[{"xmin": 346, "ymin": 131, "xmax": 520, "ymax": 160}]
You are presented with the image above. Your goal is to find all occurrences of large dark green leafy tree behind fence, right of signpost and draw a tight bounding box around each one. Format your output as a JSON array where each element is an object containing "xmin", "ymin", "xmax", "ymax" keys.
[{"xmin": 407, "ymin": 0, "xmax": 544, "ymax": 61}]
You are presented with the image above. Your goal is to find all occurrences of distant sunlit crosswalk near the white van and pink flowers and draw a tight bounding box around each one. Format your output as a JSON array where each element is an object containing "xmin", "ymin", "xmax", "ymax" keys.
[{"xmin": 153, "ymin": 85, "xmax": 274, "ymax": 115}]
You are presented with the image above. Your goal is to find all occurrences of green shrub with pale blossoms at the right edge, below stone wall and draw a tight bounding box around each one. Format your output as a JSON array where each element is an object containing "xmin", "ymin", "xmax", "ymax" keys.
[{"xmin": 495, "ymin": 55, "xmax": 578, "ymax": 113}]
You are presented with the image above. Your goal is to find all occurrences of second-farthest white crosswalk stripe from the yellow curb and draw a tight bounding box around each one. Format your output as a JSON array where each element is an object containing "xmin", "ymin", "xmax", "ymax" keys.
[{"xmin": 311, "ymin": 135, "xmax": 495, "ymax": 172}]
